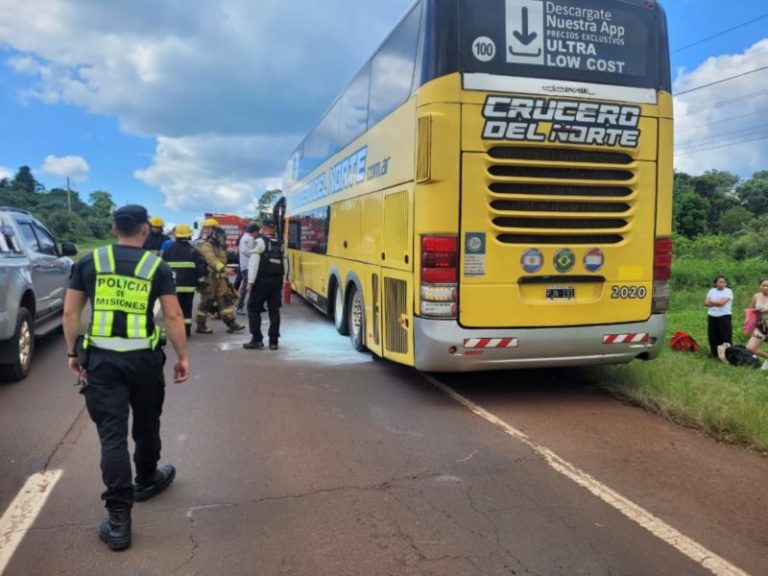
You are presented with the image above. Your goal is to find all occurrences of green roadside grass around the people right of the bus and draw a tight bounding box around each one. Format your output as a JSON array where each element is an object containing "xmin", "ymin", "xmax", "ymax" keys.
[{"xmin": 594, "ymin": 260, "xmax": 768, "ymax": 451}]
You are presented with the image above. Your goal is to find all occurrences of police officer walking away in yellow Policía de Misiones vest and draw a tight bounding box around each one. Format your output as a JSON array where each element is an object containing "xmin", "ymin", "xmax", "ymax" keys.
[{"xmin": 64, "ymin": 205, "xmax": 189, "ymax": 550}]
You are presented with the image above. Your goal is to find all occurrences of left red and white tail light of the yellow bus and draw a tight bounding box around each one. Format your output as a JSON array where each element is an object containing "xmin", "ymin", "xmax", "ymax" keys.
[{"xmin": 421, "ymin": 236, "xmax": 459, "ymax": 318}]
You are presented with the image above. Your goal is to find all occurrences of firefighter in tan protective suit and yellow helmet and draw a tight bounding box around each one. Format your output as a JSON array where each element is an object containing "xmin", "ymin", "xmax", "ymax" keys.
[{"xmin": 195, "ymin": 225, "xmax": 245, "ymax": 334}]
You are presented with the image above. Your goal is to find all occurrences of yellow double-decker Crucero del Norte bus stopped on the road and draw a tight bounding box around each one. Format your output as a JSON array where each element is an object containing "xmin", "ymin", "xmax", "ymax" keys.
[{"xmin": 284, "ymin": 0, "xmax": 673, "ymax": 371}]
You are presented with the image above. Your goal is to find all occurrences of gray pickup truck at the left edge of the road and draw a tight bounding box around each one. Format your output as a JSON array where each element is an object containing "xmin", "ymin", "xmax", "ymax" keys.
[{"xmin": 0, "ymin": 207, "xmax": 77, "ymax": 380}]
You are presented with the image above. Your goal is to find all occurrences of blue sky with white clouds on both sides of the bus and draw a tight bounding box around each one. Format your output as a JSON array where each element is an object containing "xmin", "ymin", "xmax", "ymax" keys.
[{"xmin": 0, "ymin": 0, "xmax": 768, "ymax": 223}]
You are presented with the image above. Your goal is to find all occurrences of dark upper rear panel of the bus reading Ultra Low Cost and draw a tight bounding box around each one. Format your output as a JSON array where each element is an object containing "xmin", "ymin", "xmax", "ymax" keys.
[{"xmin": 460, "ymin": 0, "xmax": 670, "ymax": 91}]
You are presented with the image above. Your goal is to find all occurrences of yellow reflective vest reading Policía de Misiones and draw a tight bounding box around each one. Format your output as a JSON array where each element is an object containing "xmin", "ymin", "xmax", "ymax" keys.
[{"xmin": 85, "ymin": 246, "xmax": 162, "ymax": 352}]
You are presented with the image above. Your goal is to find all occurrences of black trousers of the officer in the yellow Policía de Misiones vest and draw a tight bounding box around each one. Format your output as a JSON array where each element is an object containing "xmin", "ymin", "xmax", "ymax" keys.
[{"xmin": 83, "ymin": 348, "xmax": 165, "ymax": 509}]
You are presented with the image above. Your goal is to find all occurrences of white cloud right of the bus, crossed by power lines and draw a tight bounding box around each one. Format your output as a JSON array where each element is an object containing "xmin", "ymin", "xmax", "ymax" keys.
[{"xmin": 675, "ymin": 39, "xmax": 768, "ymax": 177}]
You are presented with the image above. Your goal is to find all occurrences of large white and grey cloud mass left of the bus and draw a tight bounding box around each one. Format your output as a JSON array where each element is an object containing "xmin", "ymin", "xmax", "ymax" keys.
[{"xmin": 0, "ymin": 0, "xmax": 412, "ymax": 209}]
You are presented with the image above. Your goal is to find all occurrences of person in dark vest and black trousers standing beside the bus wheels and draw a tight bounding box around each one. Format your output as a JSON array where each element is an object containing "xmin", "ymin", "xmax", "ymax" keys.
[{"xmin": 243, "ymin": 220, "xmax": 285, "ymax": 350}]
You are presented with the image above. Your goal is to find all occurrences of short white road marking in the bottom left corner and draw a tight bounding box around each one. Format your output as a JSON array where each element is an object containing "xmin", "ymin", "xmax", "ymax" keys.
[{"xmin": 0, "ymin": 470, "xmax": 62, "ymax": 575}]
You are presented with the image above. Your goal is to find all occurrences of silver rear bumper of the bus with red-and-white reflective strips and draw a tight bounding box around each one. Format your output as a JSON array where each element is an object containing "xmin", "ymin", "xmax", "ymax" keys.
[{"xmin": 414, "ymin": 314, "xmax": 667, "ymax": 372}]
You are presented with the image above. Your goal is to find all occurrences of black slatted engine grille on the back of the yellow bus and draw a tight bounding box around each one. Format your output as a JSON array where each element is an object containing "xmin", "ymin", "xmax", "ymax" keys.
[{"xmin": 486, "ymin": 146, "xmax": 638, "ymax": 245}]
